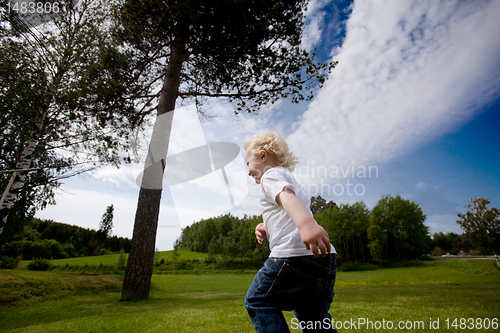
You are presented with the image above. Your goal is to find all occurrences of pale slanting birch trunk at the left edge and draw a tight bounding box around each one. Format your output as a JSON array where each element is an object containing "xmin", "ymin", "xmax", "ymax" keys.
[{"xmin": 0, "ymin": 114, "xmax": 45, "ymax": 234}]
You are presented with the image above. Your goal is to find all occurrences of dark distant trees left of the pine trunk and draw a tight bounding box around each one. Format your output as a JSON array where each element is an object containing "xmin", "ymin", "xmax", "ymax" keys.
[{"xmin": 0, "ymin": 218, "xmax": 131, "ymax": 260}]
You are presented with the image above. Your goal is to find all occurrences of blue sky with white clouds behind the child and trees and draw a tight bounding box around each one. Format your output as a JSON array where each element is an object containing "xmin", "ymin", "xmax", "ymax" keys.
[{"xmin": 37, "ymin": 0, "xmax": 500, "ymax": 250}]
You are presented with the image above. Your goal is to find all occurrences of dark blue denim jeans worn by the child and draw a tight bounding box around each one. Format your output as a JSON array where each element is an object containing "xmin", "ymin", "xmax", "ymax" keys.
[{"xmin": 245, "ymin": 254, "xmax": 337, "ymax": 333}]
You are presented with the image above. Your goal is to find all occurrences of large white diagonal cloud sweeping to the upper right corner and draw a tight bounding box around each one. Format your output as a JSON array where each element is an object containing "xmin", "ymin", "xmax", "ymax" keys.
[{"xmin": 288, "ymin": 1, "xmax": 500, "ymax": 174}]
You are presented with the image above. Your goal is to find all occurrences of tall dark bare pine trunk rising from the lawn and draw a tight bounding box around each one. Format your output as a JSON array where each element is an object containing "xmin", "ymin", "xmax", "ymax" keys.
[{"xmin": 121, "ymin": 43, "xmax": 185, "ymax": 300}]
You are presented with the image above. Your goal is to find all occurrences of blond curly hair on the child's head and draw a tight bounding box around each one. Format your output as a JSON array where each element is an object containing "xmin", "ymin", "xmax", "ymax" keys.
[{"xmin": 243, "ymin": 131, "xmax": 299, "ymax": 171}]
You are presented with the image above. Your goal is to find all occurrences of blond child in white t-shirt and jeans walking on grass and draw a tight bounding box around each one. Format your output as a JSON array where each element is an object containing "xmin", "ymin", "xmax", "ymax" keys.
[{"xmin": 244, "ymin": 132, "xmax": 337, "ymax": 333}]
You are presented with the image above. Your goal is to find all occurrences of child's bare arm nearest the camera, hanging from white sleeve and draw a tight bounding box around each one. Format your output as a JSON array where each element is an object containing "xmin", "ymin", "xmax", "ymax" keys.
[{"xmin": 276, "ymin": 187, "xmax": 331, "ymax": 257}]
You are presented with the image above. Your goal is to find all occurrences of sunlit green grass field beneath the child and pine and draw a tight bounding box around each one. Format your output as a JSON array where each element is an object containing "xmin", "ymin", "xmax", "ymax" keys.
[{"xmin": 0, "ymin": 260, "xmax": 500, "ymax": 332}]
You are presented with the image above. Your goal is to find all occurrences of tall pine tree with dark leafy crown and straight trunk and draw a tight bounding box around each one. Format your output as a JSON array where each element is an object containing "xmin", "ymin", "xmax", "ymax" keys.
[{"xmin": 117, "ymin": 0, "xmax": 336, "ymax": 300}]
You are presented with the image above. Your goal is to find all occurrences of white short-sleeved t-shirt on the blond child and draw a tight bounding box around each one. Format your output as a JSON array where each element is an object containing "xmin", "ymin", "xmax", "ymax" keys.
[{"xmin": 260, "ymin": 166, "xmax": 335, "ymax": 258}]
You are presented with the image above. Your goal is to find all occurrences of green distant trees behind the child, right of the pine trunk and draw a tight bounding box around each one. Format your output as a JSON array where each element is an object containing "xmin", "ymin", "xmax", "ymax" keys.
[{"xmin": 180, "ymin": 195, "xmax": 479, "ymax": 264}]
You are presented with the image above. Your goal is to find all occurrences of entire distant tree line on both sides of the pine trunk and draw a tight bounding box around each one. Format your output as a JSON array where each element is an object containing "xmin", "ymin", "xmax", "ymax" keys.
[{"xmin": 0, "ymin": 196, "xmax": 480, "ymax": 264}]
